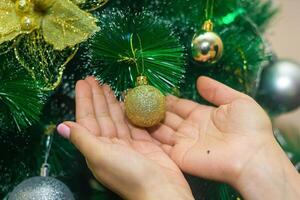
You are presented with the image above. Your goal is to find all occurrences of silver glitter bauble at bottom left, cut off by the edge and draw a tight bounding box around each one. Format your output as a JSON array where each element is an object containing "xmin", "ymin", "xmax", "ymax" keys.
[{"xmin": 8, "ymin": 176, "xmax": 74, "ymax": 200}]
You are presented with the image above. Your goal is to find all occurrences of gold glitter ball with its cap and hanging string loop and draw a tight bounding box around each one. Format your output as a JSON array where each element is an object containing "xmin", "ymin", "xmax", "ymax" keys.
[{"xmin": 125, "ymin": 34, "xmax": 166, "ymax": 128}]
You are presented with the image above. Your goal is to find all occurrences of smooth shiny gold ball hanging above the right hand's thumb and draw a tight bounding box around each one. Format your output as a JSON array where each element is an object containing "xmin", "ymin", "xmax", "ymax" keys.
[{"xmin": 192, "ymin": 30, "xmax": 223, "ymax": 64}]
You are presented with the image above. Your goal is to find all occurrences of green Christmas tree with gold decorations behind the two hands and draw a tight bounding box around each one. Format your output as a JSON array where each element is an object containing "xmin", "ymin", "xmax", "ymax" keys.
[{"xmin": 0, "ymin": 0, "xmax": 298, "ymax": 199}]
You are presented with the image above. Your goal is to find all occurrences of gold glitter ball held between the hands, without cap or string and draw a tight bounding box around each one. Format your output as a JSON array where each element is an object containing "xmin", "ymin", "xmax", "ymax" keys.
[{"xmin": 125, "ymin": 77, "xmax": 166, "ymax": 128}]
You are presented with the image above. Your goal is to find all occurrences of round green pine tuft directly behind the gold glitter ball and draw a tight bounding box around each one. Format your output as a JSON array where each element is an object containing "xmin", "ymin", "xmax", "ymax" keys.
[{"xmin": 90, "ymin": 9, "xmax": 185, "ymax": 95}]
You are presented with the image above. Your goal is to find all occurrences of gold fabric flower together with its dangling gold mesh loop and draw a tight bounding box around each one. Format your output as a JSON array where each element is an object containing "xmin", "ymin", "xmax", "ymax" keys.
[{"xmin": 0, "ymin": 0, "xmax": 108, "ymax": 91}]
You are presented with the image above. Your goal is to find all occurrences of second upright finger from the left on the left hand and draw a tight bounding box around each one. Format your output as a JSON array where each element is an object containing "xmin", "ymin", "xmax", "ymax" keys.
[{"xmin": 86, "ymin": 77, "xmax": 117, "ymax": 138}]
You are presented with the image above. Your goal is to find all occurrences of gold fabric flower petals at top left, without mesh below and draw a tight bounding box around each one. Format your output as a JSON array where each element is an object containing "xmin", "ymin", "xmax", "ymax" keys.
[{"xmin": 0, "ymin": 0, "xmax": 107, "ymax": 51}]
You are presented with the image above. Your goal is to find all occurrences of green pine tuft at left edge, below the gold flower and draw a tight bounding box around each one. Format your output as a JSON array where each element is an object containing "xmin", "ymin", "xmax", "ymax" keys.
[{"xmin": 0, "ymin": 53, "xmax": 45, "ymax": 130}]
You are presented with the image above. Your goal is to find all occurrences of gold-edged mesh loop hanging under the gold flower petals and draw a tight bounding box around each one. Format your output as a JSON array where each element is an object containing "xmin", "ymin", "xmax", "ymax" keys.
[{"xmin": 14, "ymin": 30, "xmax": 79, "ymax": 91}]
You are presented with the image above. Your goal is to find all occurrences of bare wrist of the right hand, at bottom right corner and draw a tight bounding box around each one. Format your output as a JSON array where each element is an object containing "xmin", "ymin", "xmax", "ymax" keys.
[{"xmin": 232, "ymin": 141, "xmax": 300, "ymax": 200}]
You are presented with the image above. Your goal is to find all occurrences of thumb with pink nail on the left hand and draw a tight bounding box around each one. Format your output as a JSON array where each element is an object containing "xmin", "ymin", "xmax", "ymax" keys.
[{"xmin": 57, "ymin": 122, "xmax": 99, "ymax": 159}]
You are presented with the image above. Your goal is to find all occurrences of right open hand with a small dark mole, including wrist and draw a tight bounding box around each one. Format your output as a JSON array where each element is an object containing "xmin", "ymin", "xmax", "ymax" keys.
[{"xmin": 150, "ymin": 77, "xmax": 300, "ymax": 199}]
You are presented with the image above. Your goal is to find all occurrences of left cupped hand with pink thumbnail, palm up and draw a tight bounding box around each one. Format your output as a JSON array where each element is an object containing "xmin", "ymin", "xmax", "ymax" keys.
[{"xmin": 58, "ymin": 77, "xmax": 193, "ymax": 200}]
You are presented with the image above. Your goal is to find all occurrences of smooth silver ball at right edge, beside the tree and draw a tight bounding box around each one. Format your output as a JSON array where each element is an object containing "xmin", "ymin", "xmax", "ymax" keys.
[{"xmin": 257, "ymin": 60, "xmax": 300, "ymax": 114}]
